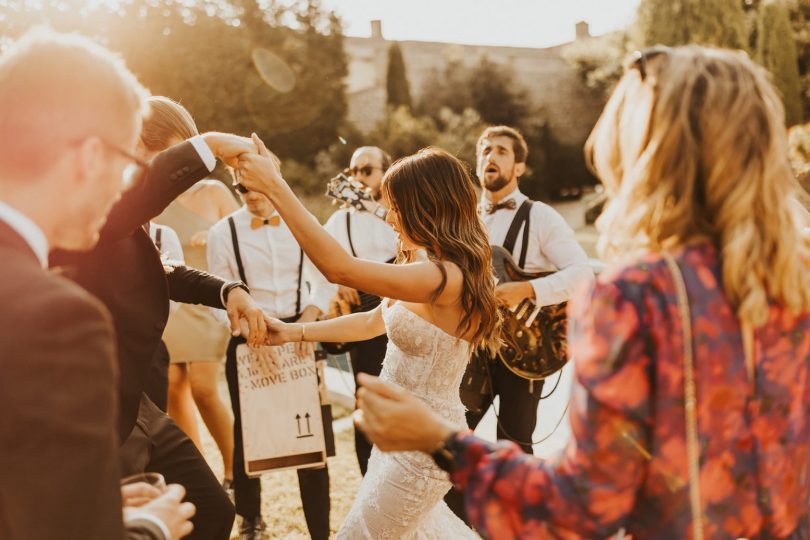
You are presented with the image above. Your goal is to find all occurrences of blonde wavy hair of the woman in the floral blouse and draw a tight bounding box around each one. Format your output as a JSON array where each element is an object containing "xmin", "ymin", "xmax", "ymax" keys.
[{"xmin": 585, "ymin": 45, "xmax": 810, "ymax": 326}]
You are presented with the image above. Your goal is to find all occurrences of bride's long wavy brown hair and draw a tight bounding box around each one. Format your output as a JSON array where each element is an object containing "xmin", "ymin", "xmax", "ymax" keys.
[{"xmin": 382, "ymin": 148, "xmax": 500, "ymax": 353}]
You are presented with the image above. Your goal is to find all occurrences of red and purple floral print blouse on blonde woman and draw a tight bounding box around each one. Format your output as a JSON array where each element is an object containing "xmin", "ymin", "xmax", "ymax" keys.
[{"xmin": 451, "ymin": 243, "xmax": 810, "ymax": 540}]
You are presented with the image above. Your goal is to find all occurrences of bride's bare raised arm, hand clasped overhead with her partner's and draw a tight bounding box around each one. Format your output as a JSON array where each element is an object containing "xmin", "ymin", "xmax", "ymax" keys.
[{"xmin": 239, "ymin": 134, "xmax": 461, "ymax": 304}]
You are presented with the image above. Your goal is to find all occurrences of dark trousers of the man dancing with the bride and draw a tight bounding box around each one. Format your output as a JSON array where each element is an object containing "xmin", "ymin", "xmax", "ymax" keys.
[{"xmin": 121, "ymin": 395, "xmax": 234, "ymax": 540}]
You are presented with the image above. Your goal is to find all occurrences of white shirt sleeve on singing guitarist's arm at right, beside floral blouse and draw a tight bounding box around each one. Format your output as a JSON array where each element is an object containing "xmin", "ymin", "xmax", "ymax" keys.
[{"xmin": 531, "ymin": 203, "xmax": 594, "ymax": 306}]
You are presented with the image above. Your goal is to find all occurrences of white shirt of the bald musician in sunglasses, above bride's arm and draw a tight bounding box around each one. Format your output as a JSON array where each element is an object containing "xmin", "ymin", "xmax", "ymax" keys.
[{"xmin": 324, "ymin": 208, "xmax": 397, "ymax": 262}]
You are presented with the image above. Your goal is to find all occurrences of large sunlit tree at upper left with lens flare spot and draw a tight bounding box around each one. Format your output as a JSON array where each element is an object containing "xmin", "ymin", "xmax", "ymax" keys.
[{"xmin": 0, "ymin": 0, "xmax": 348, "ymax": 164}]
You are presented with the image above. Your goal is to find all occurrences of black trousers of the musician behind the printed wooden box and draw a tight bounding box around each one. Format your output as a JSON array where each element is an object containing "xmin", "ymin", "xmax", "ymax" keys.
[{"xmin": 225, "ymin": 337, "xmax": 330, "ymax": 540}]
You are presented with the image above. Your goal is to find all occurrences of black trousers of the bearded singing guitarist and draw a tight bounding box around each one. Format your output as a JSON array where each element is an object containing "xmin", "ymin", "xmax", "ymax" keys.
[{"xmin": 444, "ymin": 359, "xmax": 543, "ymax": 524}]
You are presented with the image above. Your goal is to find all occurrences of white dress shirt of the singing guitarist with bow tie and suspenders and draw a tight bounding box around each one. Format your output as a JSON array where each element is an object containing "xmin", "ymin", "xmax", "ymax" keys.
[{"xmin": 479, "ymin": 189, "xmax": 594, "ymax": 306}]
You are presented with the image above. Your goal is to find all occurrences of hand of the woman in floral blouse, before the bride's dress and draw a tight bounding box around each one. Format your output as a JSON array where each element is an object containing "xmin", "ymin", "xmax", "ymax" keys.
[{"xmin": 354, "ymin": 373, "xmax": 453, "ymax": 453}]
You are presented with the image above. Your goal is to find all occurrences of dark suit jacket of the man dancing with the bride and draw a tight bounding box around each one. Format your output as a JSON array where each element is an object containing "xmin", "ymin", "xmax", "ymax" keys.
[{"xmin": 51, "ymin": 142, "xmax": 224, "ymax": 442}]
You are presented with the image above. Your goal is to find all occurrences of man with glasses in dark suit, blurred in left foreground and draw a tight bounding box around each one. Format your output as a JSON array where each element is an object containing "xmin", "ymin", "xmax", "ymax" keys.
[{"xmin": 0, "ymin": 28, "xmax": 194, "ymax": 540}]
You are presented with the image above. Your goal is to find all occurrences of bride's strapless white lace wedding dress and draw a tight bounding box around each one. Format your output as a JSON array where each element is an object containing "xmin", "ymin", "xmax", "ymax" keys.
[{"xmin": 337, "ymin": 300, "xmax": 479, "ymax": 540}]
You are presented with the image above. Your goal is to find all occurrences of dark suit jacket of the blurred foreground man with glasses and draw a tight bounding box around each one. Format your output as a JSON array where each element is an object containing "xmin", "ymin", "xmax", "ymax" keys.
[{"xmin": 0, "ymin": 222, "xmax": 123, "ymax": 540}]
